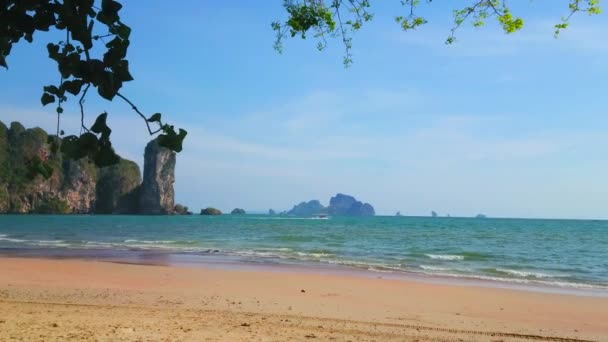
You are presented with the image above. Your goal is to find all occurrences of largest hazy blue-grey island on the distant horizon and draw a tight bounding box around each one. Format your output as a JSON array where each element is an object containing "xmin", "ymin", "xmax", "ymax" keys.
[{"xmin": 285, "ymin": 193, "xmax": 376, "ymax": 217}]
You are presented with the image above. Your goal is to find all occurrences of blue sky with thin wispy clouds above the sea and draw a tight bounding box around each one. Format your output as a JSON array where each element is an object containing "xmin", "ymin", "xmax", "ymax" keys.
[{"xmin": 0, "ymin": 0, "xmax": 608, "ymax": 218}]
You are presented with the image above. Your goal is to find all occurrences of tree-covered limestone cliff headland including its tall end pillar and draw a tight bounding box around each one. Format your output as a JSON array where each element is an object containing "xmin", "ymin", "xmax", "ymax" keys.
[{"xmin": 0, "ymin": 121, "xmax": 184, "ymax": 215}]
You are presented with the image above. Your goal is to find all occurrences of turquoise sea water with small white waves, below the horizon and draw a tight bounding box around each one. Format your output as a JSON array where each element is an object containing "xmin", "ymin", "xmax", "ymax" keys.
[{"xmin": 0, "ymin": 215, "xmax": 608, "ymax": 291}]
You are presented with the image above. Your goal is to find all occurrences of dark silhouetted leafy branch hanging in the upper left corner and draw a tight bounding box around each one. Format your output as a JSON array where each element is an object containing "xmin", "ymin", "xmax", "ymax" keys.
[{"xmin": 0, "ymin": 0, "xmax": 187, "ymax": 170}]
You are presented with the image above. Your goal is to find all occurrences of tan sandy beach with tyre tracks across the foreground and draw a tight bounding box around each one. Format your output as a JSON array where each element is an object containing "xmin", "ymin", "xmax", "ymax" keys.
[{"xmin": 0, "ymin": 257, "xmax": 608, "ymax": 341}]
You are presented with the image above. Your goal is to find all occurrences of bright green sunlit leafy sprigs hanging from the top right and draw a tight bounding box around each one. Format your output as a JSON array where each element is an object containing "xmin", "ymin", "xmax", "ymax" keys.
[{"xmin": 272, "ymin": 0, "xmax": 601, "ymax": 66}]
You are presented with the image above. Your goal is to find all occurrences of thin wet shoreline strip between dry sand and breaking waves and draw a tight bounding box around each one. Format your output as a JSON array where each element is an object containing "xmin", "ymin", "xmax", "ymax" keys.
[{"xmin": 0, "ymin": 248, "xmax": 608, "ymax": 298}]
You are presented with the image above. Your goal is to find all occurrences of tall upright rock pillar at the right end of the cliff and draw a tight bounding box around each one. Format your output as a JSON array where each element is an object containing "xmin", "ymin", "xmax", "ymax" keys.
[{"xmin": 139, "ymin": 140, "xmax": 176, "ymax": 215}]
